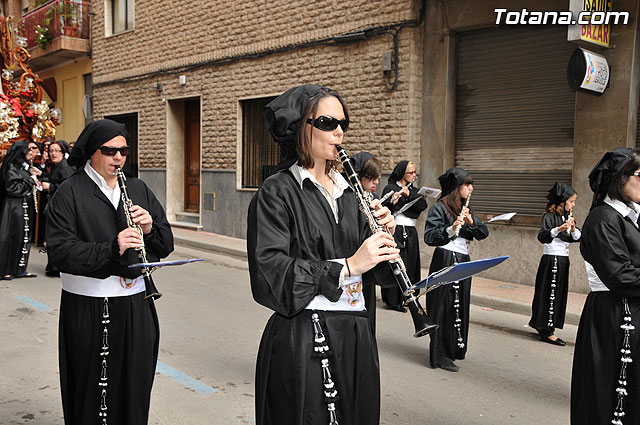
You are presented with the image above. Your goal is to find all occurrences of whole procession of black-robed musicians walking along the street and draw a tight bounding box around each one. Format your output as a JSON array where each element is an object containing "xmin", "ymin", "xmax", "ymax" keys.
[{"xmin": 0, "ymin": 85, "xmax": 640, "ymax": 425}]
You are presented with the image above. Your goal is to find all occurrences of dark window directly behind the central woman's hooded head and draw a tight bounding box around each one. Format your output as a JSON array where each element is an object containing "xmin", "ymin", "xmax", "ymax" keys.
[{"xmin": 240, "ymin": 97, "xmax": 280, "ymax": 188}]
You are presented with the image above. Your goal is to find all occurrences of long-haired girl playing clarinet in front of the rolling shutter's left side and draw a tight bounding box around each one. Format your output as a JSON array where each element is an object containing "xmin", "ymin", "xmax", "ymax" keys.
[{"xmin": 424, "ymin": 168, "xmax": 489, "ymax": 372}]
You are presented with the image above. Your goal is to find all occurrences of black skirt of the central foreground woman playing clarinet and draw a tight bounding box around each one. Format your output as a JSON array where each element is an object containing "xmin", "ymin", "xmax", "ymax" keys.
[{"xmin": 256, "ymin": 310, "xmax": 380, "ymax": 425}]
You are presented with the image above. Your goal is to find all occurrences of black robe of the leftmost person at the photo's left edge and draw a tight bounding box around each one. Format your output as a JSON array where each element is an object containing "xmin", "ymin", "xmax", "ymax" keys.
[{"xmin": 0, "ymin": 165, "xmax": 35, "ymax": 277}]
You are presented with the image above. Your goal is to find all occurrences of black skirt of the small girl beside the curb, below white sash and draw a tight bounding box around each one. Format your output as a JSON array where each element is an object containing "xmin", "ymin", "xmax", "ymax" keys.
[{"xmin": 529, "ymin": 255, "xmax": 569, "ymax": 331}]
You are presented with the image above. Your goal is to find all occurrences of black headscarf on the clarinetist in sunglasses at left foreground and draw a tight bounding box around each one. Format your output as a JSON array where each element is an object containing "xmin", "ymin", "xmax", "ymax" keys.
[{"xmin": 67, "ymin": 120, "xmax": 130, "ymax": 170}]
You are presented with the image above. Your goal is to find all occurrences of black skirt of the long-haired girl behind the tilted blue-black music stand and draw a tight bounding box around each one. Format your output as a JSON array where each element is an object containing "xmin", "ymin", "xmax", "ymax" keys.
[{"xmin": 426, "ymin": 247, "xmax": 471, "ymax": 366}]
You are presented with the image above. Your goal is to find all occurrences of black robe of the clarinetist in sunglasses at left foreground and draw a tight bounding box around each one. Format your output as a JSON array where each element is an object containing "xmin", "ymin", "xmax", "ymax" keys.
[{"xmin": 47, "ymin": 170, "xmax": 173, "ymax": 425}]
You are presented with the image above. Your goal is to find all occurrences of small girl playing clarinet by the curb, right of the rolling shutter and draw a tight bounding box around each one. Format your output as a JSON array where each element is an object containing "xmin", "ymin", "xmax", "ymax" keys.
[{"xmin": 529, "ymin": 182, "xmax": 580, "ymax": 346}]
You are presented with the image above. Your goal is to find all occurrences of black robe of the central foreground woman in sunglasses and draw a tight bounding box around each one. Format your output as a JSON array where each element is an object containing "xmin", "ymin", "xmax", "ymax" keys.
[{"xmin": 247, "ymin": 170, "xmax": 380, "ymax": 425}]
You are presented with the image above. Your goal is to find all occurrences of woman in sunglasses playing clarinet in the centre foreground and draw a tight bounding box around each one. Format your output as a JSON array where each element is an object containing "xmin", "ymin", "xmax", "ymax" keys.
[{"xmin": 247, "ymin": 85, "xmax": 398, "ymax": 425}]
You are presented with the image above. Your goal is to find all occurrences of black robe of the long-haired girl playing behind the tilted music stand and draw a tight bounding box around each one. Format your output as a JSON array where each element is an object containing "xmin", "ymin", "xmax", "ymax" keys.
[{"xmin": 424, "ymin": 202, "xmax": 489, "ymax": 366}]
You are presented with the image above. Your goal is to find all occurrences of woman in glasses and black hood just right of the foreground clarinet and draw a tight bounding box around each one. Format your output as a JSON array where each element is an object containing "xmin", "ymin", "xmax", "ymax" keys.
[{"xmin": 381, "ymin": 161, "xmax": 427, "ymax": 312}]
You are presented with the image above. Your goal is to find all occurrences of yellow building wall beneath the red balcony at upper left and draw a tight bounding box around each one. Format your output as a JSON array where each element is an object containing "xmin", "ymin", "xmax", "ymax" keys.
[{"xmin": 38, "ymin": 58, "xmax": 91, "ymax": 142}]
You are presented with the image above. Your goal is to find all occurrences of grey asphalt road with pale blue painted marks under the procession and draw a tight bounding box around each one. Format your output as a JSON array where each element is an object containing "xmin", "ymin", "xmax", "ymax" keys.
[{"xmin": 0, "ymin": 248, "xmax": 576, "ymax": 425}]
